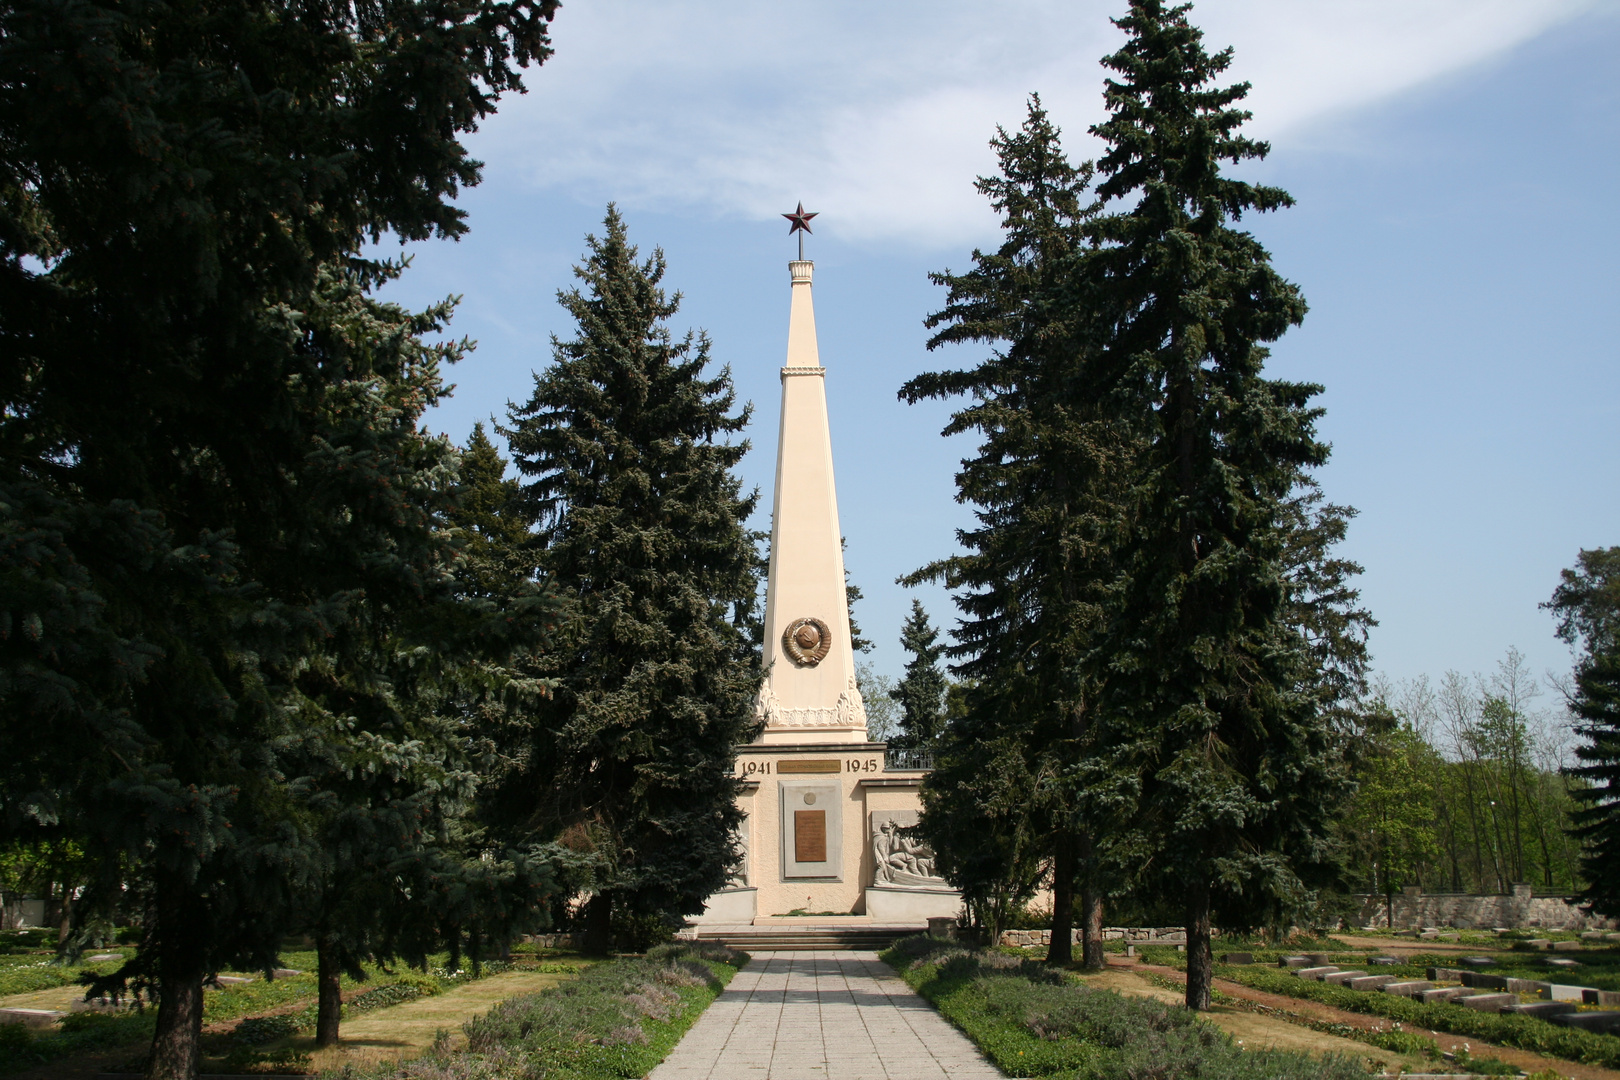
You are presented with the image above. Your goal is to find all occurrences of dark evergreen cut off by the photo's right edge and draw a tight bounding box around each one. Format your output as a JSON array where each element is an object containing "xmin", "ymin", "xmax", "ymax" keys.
[{"xmin": 1545, "ymin": 547, "xmax": 1620, "ymax": 915}]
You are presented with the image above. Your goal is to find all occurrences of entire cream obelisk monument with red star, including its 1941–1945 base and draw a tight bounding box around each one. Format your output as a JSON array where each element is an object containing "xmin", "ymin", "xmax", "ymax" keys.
[{"xmin": 697, "ymin": 204, "xmax": 961, "ymax": 929}]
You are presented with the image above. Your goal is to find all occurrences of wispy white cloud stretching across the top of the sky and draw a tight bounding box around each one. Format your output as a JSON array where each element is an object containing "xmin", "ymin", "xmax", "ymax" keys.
[{"xmin": 478, "ymin": 0, "xmax": 1602, "ymax": 248}]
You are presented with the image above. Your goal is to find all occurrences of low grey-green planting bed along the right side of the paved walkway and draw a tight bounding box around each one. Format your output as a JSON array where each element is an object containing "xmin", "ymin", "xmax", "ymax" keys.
[{"xmin": 883, "ymin": 938, "xmax": 1366, "ymax": 1080}]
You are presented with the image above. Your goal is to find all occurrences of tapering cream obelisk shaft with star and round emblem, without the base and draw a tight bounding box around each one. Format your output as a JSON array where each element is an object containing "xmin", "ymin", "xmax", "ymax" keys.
[{"xmin": 758, "ymin": 206, "xmax": 867, "ymax": 745}]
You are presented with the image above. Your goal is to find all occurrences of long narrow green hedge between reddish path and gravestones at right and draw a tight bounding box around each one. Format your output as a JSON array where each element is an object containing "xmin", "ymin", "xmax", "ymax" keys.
[{"xmin": 1217, "ymin": 965, "xmax": 1620, "ymax": 1069}]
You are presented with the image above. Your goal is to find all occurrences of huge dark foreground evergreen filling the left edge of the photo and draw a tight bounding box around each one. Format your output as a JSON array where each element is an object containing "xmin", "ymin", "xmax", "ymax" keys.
[{"xmin": 0, "ymin": 0, "xmax": 556, "ymax": 1080}]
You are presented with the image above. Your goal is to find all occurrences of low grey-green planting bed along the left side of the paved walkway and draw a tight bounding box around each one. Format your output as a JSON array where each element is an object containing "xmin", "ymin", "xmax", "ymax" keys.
[{"xmin": 322, "ymin": 942, "xmax": 748, "ymax": 1080}]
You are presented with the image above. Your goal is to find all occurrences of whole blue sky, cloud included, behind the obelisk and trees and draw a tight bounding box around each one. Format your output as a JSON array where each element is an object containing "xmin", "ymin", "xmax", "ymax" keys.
[{"xmin": 390, "ymin": 0, "xmax": 1620, "ymax": 696}]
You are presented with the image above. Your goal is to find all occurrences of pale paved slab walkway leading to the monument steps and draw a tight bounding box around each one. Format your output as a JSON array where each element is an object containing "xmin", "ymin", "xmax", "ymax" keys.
[{"xmin": 648, "ymin": 952, "xmax": 1001, "ymax": 1080}]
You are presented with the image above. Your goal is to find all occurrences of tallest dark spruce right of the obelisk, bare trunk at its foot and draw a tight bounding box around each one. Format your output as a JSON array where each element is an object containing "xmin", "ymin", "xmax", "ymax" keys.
[{"xmin": 1084, "ymin": 0, "xmax": 1345, "ymax": 1009}]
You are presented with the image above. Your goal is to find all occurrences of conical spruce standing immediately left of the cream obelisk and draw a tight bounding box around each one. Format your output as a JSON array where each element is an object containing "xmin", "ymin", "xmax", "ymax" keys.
[{"xmin": 502, "ymin": 206, "xmax": 761, "ymax": 949}]
